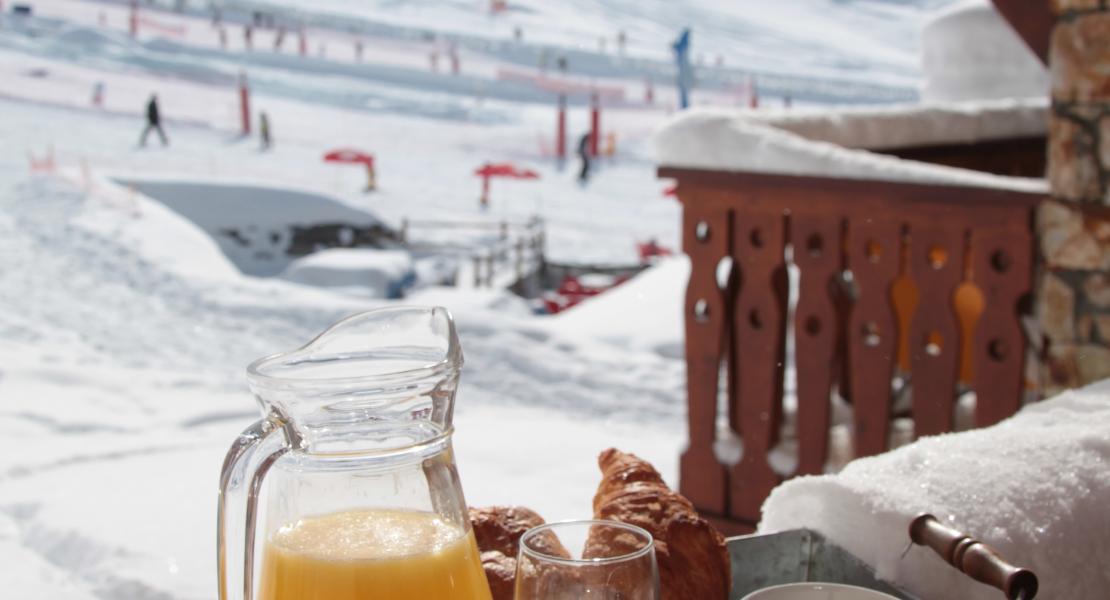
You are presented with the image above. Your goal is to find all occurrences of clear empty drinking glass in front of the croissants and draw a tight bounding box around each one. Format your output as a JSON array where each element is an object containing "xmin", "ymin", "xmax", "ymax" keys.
[{"xmin": 514, "ymin": 520, "xmax": 659, "ymax": 600}]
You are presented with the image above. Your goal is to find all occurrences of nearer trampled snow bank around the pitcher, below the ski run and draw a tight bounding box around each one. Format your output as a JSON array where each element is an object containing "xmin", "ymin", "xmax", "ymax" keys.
[{"xmin": 0, "ymin": 170, "xmax": 682, "ymax": 598}]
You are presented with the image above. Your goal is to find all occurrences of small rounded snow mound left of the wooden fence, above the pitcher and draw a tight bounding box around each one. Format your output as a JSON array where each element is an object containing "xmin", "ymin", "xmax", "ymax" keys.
[{"xmin": 281, "ymin": 248, "xmax": 415, "ymax": 298}]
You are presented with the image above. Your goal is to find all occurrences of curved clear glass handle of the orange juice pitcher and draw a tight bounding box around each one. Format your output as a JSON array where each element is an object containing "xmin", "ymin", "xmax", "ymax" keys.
[{"xmin": 216, "ymin": 415, "xmax": 292, "ymax": 600}]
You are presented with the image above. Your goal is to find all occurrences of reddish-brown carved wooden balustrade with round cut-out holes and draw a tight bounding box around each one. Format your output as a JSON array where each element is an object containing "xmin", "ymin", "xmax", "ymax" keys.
[{"xmin": 659, "ymin": 167, "xmax": 1043, "ymax": 532}]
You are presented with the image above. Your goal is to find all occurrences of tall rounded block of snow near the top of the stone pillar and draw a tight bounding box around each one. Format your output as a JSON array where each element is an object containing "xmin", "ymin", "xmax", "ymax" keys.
[{"xmin": 921, "ymin": 0, "xmax": 1049, "ymax": 102}]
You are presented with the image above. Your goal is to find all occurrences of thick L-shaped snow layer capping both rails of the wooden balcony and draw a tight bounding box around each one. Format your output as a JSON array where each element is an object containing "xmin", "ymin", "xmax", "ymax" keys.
[{"xmin": 654, "ymin": 103, "xmax": 1048, "ymax": 192}]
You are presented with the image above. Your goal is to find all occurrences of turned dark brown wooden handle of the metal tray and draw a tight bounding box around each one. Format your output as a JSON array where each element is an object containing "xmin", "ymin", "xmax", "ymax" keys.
[{"xmin": 909, "ymin": 515, "xmax": 1037, "ymax": 600}]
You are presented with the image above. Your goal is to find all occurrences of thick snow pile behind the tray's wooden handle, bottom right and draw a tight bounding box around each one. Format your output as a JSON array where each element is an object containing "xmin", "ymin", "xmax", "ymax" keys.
[{"xmin": 759, "ymin": 382, "xmax": 1110, "ymax": 600}]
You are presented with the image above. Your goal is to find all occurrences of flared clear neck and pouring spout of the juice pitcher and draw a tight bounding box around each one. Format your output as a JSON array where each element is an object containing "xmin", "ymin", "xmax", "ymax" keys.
[{"xmin": 246, "ymin": 306, "xmax": 463, "ymax": 451}]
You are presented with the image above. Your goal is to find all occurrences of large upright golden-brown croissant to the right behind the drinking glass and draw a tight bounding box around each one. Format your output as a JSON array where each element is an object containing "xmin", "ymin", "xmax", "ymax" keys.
[{"xmin": 585, "ymin": 448, "xmax": 731, "ymax": 600}]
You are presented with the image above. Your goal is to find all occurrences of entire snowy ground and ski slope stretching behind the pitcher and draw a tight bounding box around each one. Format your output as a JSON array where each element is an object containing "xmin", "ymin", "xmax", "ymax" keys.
[{"xmin": 0, "ymin": 0, "xmax": 1016, "ymax": 600}]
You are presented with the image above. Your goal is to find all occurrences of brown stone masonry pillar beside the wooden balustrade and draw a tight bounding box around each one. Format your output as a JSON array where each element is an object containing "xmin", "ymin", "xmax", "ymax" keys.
[{"xmin": 1036, "ymin": 0, "xmax": 1110, "ymax": 395}]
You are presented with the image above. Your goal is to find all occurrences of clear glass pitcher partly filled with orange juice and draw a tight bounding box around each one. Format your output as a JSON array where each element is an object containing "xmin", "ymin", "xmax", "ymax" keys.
[{"xmin": 216, "ymin": 307, "xmax": 490, "ymax": 600}]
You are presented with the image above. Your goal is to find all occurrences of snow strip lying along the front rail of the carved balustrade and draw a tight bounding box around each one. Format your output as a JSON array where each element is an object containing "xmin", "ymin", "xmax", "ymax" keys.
[{"xmin": 654, "ymin": 109, "xmax": 1048, "ymax": 193}]
